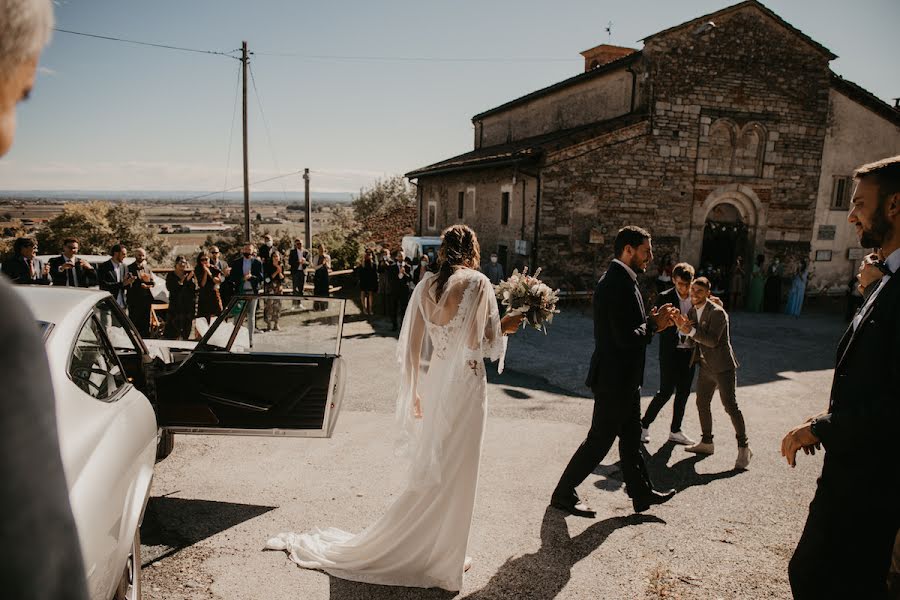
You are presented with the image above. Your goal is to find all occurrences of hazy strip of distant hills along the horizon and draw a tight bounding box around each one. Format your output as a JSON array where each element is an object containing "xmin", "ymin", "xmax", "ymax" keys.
[{"xmin": 0, "ymin": 190, "xmax": 354, "ymax": 204}]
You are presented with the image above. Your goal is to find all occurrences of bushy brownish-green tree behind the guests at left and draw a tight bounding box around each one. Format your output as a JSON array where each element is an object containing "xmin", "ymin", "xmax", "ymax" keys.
[{"xmin": 36, "ymin": 202, "xmax": 172, "ymax": 261}]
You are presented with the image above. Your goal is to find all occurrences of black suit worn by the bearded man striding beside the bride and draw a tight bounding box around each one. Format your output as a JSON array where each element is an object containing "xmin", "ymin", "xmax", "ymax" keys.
[{"xmin": 553, "ymin": 262, "xmax": 654, "ymax": 501}]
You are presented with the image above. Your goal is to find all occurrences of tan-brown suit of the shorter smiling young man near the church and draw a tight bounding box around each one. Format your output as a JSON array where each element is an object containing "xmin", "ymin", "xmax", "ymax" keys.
[{"xmin": 688, "ymin": 301, "xmax": 747, "ymax": 446}]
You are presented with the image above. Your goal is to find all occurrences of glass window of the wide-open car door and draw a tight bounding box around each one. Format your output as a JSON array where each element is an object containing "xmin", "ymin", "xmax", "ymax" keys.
[{"xmin": 201, "ymin": 296, "xmax": 346, "ymax": 356}]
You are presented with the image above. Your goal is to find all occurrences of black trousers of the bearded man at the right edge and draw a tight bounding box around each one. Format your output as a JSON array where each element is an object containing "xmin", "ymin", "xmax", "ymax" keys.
[{"xmin": 788, "ymin": 452, "xmax": 900, "ymax": 600}]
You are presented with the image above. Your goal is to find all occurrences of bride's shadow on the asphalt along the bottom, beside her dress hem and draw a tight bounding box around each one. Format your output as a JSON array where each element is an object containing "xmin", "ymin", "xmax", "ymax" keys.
[{"xmin": 330, "ymin": 506, "xmax": 665, "ymax": 600}]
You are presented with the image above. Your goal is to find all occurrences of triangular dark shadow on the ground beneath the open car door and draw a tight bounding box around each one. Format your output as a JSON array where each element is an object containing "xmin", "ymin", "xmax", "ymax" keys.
[{"xmin": 141, "ymin": 496, "xmax": 276, "ymax": 567}]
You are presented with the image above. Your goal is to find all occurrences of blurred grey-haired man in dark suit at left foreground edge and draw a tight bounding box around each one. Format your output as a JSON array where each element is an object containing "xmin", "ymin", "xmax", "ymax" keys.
[{"xmin": 0, "ymin": 0, "xmax": 89, "ymax": 600}]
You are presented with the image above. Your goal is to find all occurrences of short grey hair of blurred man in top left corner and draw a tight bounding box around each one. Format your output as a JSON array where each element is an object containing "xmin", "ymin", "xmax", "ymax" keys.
[{"xmin": 0, "ymin": 0, "xmax": 53, "ymax": 76}]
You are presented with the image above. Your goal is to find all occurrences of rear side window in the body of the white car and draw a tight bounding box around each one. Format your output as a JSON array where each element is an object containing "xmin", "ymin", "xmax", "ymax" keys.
[{"xmin": 69, "ymin": 316, "xmax": 126, "ymax": 402}]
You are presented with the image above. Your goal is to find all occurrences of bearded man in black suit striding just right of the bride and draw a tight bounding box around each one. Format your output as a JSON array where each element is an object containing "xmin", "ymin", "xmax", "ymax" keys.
[{"xmin": 550, "ymin": 225, "xmax": 678, "ymax": 518}]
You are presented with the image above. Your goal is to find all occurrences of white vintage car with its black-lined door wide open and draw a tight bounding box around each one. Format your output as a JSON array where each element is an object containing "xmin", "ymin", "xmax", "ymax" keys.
[{"xmin": 17, "ymin": 286, "xmax": 345, "ymax": 600}]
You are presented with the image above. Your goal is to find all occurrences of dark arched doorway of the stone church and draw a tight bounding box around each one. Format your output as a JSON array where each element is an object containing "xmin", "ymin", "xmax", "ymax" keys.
[{"xmin": 697, "ymin": 202, "xmax": 751, "ymax": 298}]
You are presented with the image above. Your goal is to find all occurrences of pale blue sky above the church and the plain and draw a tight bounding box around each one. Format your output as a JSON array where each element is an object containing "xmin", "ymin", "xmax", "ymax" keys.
[{"xmin": 0, "ymin": 0, "xmax": 900, "ymax": 192}]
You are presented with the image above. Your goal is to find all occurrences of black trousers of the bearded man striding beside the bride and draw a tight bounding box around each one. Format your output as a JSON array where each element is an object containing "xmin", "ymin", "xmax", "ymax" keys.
[{"xmin": 553, "ymin": 388, "xmax": 653, "ymax": 499}]
